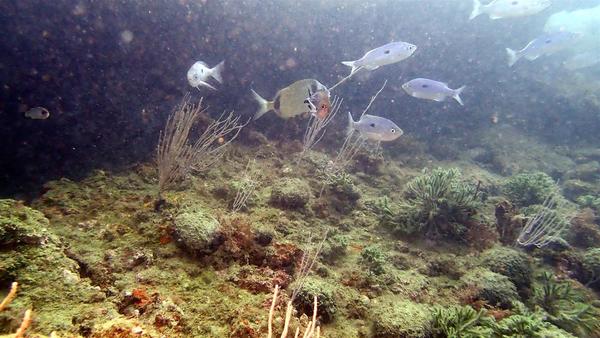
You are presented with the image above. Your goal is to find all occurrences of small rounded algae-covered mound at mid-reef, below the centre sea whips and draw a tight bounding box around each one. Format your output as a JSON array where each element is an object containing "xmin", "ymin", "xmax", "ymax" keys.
[{"xmin": 271, "ymin": 178, "xmax": 310, "ymax": 209}]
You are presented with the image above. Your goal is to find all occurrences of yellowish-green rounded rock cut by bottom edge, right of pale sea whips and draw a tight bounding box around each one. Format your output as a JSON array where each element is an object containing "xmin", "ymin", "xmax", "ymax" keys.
[{"xmin": 371, "ymin": 300, "xmax": 432, "ymax": 338}]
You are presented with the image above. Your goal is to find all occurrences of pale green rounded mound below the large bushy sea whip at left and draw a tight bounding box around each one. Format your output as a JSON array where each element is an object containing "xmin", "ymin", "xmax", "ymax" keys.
[{"xmin": 173, "ymin": 207, "xmax": 223, "ymax": 255}]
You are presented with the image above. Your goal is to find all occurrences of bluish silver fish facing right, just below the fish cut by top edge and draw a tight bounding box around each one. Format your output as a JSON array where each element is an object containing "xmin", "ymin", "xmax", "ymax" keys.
[{"xmin": 506, "ymin": 31, "xmax": 581, "ymax": 67}]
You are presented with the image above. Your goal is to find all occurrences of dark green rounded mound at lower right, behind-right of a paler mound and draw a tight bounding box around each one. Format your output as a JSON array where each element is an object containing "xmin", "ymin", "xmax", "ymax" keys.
[{"xmin": 481, "ymin": 247, "xmax": 533, "ymax": 289}]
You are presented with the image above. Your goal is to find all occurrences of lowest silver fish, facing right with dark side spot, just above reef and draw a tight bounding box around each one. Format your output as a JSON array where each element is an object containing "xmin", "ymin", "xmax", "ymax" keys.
[{"xmin": 348, "ymin": 112, "xmax": 404, "ymax": 142}]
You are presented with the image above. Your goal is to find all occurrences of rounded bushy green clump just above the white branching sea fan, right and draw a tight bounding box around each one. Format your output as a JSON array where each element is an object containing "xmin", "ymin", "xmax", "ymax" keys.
[{"xmin": 502, "ymin": 171, "xmax": 558, "ymax": 207}]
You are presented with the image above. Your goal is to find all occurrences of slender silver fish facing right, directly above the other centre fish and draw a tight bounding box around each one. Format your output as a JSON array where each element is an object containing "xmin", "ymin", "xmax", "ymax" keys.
[{"xmin": 342, "ymin": 41, "xmax": 417, "ymax": 74}]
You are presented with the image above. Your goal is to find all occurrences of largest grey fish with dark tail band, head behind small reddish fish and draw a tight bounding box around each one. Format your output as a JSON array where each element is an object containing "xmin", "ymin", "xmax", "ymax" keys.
[{"xmin": 251, "ymin": 79, "xmax": 327, "ymax": 120}]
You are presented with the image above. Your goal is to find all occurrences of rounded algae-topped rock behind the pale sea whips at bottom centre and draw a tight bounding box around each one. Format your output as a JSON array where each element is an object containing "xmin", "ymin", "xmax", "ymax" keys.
[{"xmin": 294, "ymin": 277, "xmax": 337, "ymax": 323}]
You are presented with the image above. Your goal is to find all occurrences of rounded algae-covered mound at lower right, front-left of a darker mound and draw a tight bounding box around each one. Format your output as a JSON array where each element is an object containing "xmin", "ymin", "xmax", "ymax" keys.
[{"xmin": 461, "ymin": 269, "xmax": 519, "ymax": 309}]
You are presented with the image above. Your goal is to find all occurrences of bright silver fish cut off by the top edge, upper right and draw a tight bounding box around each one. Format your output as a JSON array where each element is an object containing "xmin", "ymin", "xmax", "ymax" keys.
[{"xmin": 469, "ymin": 0, "xmax": 552, "ymax": 20}]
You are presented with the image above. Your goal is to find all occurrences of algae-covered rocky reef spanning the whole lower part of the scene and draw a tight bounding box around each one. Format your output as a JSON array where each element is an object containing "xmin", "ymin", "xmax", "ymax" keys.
[{"xmin": 0, "ymin": 122, "xmax": 600, "ymax": 337}]
